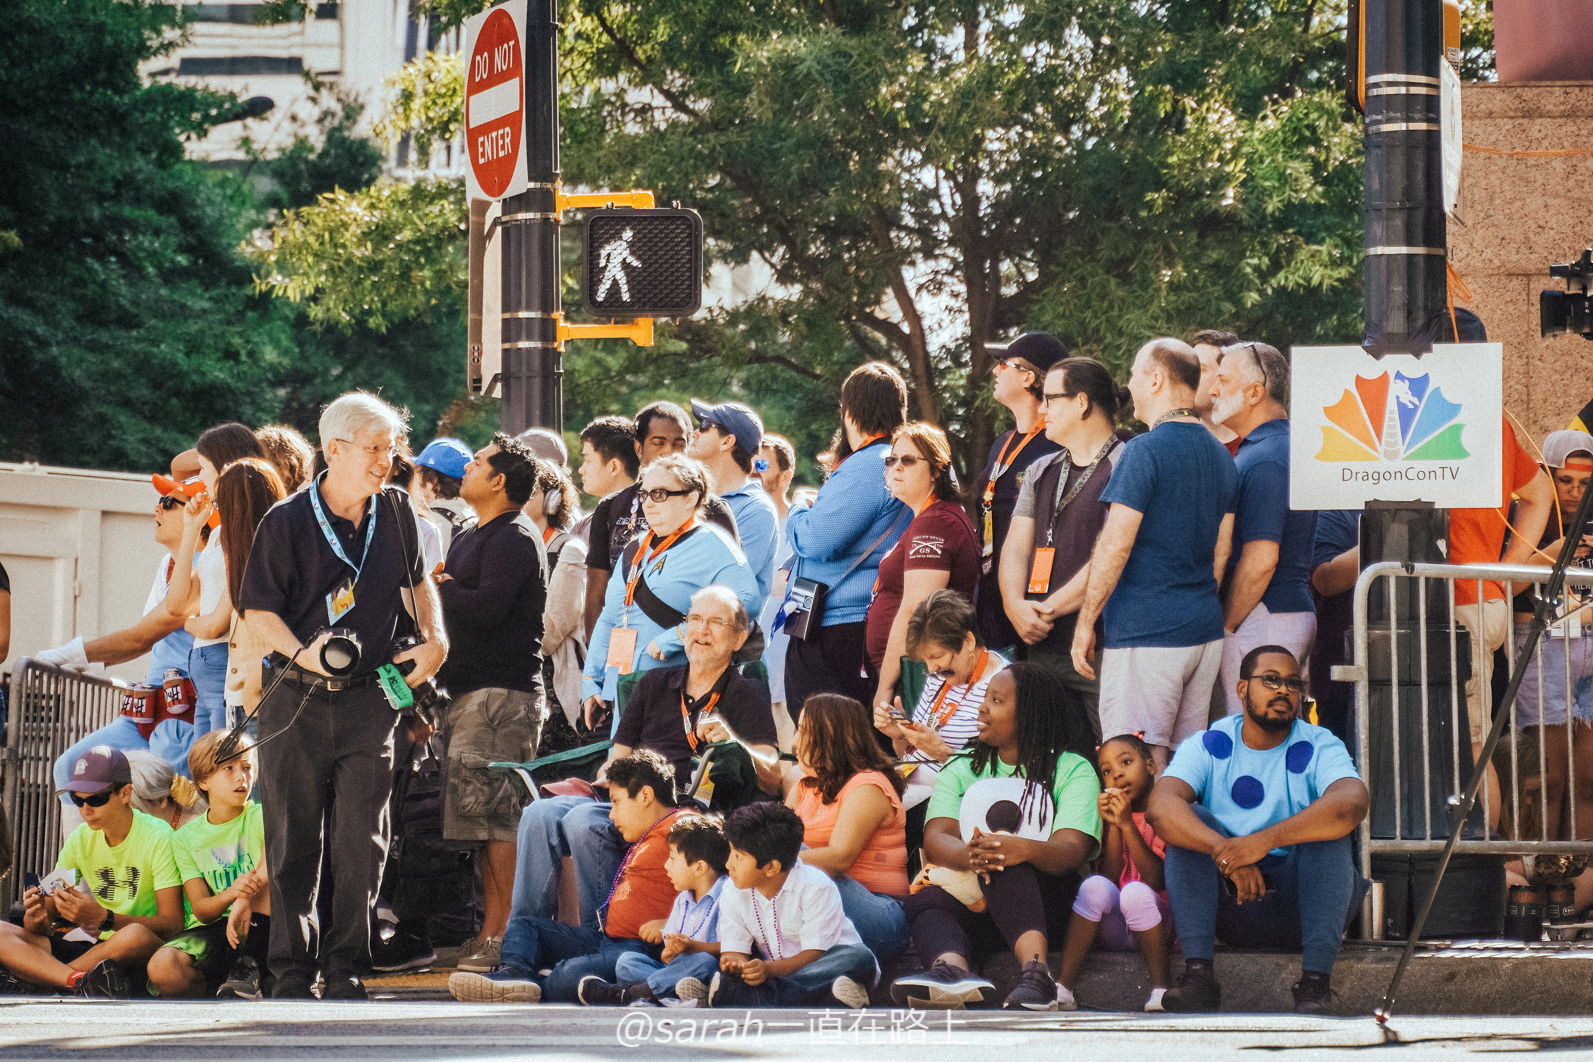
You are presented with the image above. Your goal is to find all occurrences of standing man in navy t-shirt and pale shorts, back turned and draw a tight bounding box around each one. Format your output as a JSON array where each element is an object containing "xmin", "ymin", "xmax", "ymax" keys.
[{"xmin": 1072, "ymin": 339, "xmax": 1238, "ymax": 767}]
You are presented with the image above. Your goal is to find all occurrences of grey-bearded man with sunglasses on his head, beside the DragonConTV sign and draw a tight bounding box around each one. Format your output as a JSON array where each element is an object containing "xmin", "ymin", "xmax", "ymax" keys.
[{"xmin": 1211, "ymin": 342, "xmax": 1316, "ymax": 715}]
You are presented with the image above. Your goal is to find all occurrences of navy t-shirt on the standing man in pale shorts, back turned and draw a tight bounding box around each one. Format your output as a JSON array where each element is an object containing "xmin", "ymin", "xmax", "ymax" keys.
[{"xmin": 1101, "ymin": 420, "xmax": 1239, "ymax": 650}]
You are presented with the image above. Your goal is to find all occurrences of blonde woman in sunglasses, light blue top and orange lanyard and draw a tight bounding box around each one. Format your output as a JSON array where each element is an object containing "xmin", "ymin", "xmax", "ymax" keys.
[{"xmin": 581, "ymin": 454, "xmax": 763, "ymax": 726}]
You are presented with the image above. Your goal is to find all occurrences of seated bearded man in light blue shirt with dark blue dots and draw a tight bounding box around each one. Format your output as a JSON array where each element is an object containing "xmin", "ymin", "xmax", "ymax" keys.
[{"xmin": 1149, "ymin": 645, "xmax": 1368, "ymax": 1014}]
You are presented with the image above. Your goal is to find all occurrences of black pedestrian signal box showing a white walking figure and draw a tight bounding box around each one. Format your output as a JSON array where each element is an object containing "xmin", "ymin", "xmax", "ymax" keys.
[{"xmin": 581, "ymin": 207, "xmax": 703, "ymax": 317}]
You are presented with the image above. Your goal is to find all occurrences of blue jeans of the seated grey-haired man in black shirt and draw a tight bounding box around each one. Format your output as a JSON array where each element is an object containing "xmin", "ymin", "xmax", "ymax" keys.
[{"xmin": 510, "ymin": 796, "xmax": 628, "ymax": 925}]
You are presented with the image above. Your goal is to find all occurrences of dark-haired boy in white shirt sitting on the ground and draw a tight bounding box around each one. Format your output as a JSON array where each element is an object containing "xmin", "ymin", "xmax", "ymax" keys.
[{"xmin": 707, "ymin": 802, "xmax": 879, "ymax": 1009}]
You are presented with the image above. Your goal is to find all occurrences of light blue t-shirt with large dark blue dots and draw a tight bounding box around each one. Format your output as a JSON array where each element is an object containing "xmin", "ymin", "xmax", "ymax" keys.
[{"xmin": 1168, "ymin": 715, "xmax": 1360, "ymax": 852}]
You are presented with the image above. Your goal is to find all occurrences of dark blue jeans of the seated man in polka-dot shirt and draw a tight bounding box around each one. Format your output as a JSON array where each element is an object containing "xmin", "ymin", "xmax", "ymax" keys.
[{"xmin": 1166, "ymin": 804, "xmax": 1367, "ymax": 973}]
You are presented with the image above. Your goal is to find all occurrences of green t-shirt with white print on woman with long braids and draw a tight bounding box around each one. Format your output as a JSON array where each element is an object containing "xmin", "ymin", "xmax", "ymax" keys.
[{"xmin": 926, "ymin": 752, "xmax": 1101, "ymax": 858}]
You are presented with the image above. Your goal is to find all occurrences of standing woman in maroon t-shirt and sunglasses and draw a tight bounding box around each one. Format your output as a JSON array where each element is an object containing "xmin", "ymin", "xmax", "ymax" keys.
[{"xmin": 867, "ymin": 420, "xmax": 980, "ymax": 709}]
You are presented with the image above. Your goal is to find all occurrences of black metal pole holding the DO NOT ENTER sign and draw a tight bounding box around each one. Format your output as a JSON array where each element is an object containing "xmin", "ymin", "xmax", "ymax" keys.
[{"xmin": 502, "ymin": 0, "xmax": 564, "ymax": 435}]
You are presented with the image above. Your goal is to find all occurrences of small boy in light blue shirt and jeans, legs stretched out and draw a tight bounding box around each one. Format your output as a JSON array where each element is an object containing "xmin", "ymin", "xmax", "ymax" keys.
[{"xmin": 577, "ymin": 815, "xmax": 730, "ymax": 1006}]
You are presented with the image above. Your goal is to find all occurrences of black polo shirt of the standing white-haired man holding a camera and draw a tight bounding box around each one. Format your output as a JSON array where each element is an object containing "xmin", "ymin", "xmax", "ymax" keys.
[{"xmin": 237, "ymin": 481, "xmax": 425, "ymax": 675}]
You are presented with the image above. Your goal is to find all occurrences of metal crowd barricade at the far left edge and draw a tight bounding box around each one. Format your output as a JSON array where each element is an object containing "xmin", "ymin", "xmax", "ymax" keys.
[{"xmin": 0, "ymin": 658, "xmax": 127, "ymax": 911}]
